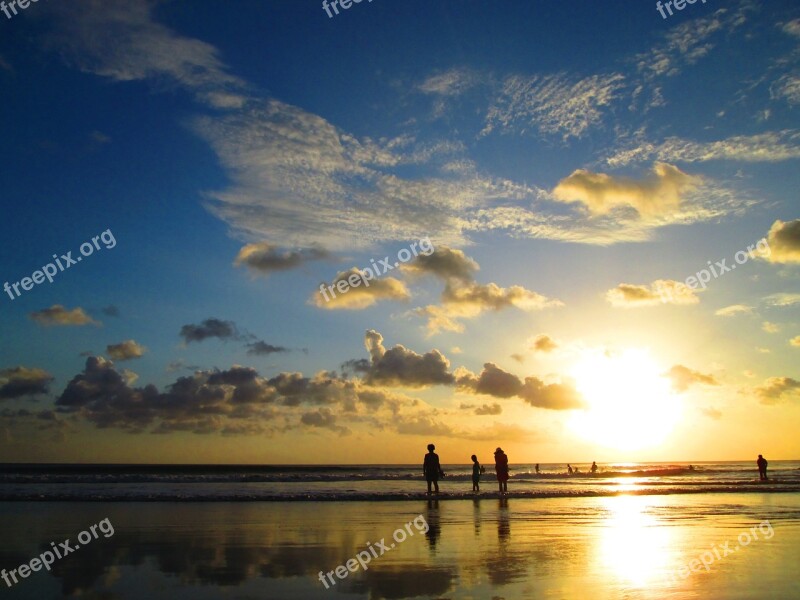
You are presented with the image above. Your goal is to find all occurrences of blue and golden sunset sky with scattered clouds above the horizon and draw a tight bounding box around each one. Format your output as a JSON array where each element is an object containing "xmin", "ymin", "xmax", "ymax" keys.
[{"xmin": 0, "ymin": 0, "xmax": 800, "ymax": 464}]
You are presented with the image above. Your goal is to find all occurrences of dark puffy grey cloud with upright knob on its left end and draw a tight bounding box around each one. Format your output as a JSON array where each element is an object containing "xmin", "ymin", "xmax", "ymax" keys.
[{"xmin": 364, "ymin": 329, "xmax": 455, "ymax": 387}]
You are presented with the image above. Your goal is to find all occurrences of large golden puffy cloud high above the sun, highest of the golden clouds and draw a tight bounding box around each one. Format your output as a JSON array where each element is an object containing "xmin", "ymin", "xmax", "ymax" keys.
[{"xmin": 553, "ymin": 162, "xmax": 702, "ymax": 218}]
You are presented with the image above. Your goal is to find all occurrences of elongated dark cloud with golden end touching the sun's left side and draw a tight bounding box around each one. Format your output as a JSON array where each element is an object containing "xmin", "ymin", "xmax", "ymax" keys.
[{"xmin": 455, "ymin": 363, "xmax": 585, "ymax": 410}]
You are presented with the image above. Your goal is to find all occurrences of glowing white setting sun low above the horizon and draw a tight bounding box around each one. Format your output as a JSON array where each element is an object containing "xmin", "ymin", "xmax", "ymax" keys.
[{"xmin": 570, "ymin": 349, "xmax": 682, "ymax": 450}]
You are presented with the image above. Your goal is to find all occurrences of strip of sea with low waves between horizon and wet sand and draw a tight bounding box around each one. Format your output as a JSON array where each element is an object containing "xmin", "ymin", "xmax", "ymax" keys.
[{"xmin": 0, "ymin": 461, "xmax": 800, "ymax": 502}]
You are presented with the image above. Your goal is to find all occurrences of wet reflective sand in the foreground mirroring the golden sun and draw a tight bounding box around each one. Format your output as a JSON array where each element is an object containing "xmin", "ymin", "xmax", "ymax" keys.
[{"xmin": 0, "ymin": 494, "xmax": 800, "ymax": 600}]
